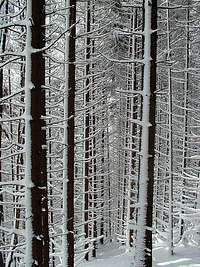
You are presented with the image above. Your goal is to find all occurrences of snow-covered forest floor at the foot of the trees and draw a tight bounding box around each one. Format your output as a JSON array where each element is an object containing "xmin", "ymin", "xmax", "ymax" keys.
[{"xmin": 80, "ymin": 240, "xmax": 200, "ymax": 267}]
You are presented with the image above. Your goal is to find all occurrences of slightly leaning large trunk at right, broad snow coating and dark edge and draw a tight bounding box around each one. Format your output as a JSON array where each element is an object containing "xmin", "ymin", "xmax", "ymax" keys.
[{"xmin": 135, "ymin": 0, "xmax": 157, "ymax": 267}]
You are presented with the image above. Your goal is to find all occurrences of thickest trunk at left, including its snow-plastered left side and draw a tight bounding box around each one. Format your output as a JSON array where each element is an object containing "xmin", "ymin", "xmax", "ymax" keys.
[{"xmin": 25, "ymin": 0, "xmax": 49, "ymax": 267}]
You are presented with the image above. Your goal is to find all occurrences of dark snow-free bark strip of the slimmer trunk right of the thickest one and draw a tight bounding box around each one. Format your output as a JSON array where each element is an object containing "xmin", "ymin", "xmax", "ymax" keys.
[{"xmin": 67, "ymin": 0, "xmax": 76, "ymax": 267}]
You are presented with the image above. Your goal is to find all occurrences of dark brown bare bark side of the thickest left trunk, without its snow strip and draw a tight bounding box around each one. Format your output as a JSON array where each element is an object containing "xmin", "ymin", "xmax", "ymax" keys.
[{"xmin": 26, "ymin": 0, "xmax": 49, "ymax": 267}]
